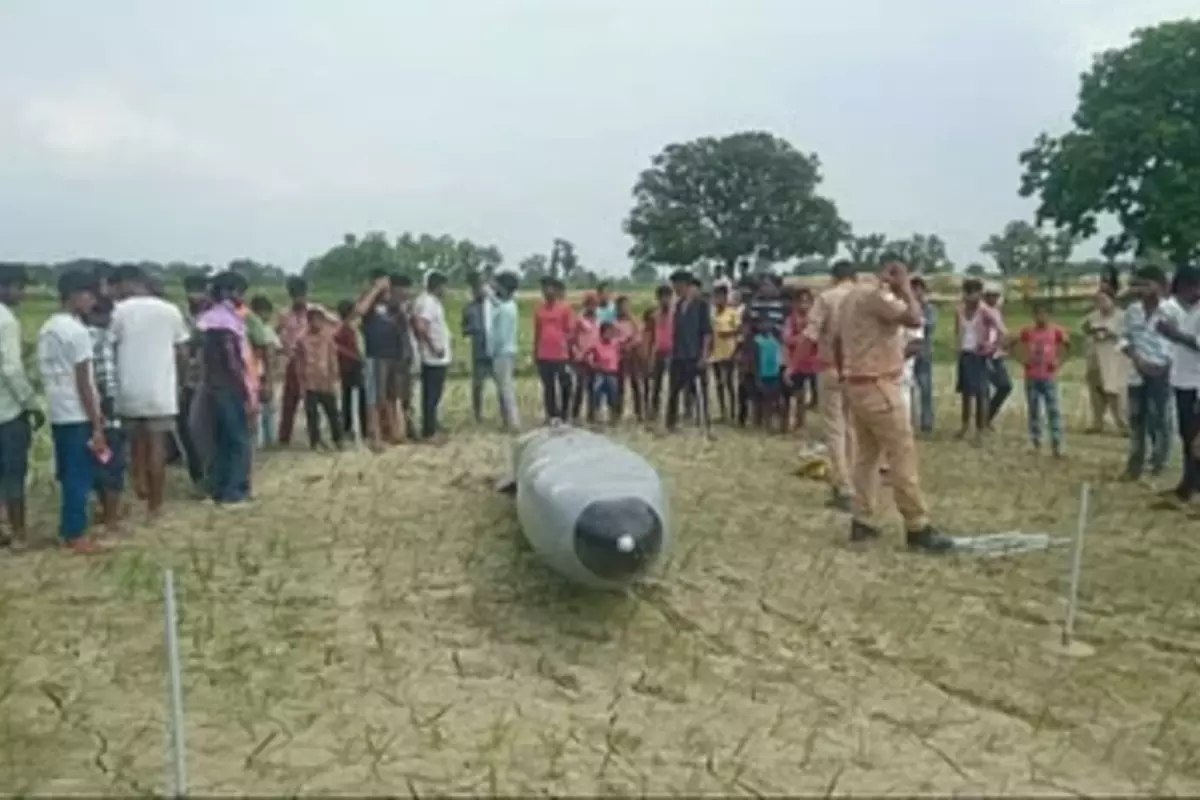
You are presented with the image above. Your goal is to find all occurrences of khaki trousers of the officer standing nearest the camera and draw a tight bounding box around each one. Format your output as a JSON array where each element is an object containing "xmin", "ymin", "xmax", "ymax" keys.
[{"xmin": 842, "ymin": 377, "xmax": 929, "ymax": 531}]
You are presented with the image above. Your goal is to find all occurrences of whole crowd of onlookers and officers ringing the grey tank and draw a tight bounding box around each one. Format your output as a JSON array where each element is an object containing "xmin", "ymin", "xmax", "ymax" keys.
[{"xmin": 0, "ymin": 257, "xmax": 1200, "ymax": 553}]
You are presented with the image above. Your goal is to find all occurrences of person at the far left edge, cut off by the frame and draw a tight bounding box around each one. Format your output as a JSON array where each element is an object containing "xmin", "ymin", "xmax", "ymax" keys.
[{"xmin": 0, "ymin": 264, "xmax": 46, "ymax": 551}]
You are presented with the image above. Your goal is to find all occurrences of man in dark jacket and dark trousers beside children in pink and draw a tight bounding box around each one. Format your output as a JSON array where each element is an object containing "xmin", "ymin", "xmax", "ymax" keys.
[{"xmin": 666, "ymin": 270, "xmax": 713, "ymax": 431}]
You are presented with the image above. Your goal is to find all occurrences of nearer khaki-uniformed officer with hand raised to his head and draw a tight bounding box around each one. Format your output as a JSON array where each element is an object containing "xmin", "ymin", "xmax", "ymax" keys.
[{"xmin": 834, "ymin": 255, "xmax": 954, "ymax": 553}]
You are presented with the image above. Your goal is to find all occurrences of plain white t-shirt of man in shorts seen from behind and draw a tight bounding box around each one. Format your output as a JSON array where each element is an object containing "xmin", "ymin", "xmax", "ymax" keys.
[{"xmin": 109, "ymin": 295, "xmax": 191, "ymax": 417}]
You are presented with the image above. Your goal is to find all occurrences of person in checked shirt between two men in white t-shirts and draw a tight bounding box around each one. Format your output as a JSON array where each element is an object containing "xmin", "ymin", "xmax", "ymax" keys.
[{"xmin": 88, "ymin": 296, "xmax": 125, "ymax": 535}]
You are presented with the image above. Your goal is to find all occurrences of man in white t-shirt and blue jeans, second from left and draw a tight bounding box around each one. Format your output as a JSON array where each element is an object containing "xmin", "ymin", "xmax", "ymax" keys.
[{"xmin": 37, "ymin": 272, "xmax": 108, "ymax": 554}]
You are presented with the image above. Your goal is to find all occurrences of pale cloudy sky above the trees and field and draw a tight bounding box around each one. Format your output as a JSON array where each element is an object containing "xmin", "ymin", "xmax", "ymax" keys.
[{"xmin": 0, "ymin": 0, "xmax": 1196, "ymax": 273}]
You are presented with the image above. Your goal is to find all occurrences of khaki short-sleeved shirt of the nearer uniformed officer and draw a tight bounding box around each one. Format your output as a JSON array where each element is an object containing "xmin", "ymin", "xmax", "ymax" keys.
[{"xmin": 836, "ymin": 284, "xmax": 907, "ymax": 380}]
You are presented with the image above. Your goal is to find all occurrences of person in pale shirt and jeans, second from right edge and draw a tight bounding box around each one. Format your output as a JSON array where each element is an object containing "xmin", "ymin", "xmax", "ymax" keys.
[{"xmin": 1121, "ymin": 266, "xmax": 1171, "ymax": 481}]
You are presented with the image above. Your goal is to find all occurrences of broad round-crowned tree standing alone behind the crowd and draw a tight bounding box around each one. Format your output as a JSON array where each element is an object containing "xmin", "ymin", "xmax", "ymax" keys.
[{"xmin": 625, "ymin": 131, "xmax": 847, "ymax": 273}]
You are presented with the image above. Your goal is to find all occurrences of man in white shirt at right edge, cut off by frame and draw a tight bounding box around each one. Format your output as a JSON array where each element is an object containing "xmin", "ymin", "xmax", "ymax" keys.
[{"xmin": 1158, "ymin": 266, "xmax": 1200, "ymax": 503}]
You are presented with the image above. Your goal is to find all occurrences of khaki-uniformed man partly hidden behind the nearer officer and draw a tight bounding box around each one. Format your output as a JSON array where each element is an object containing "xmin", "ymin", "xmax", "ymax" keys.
[{"xmin": 804, "ymin": 260, "xmax": 856, "ymax": 511}]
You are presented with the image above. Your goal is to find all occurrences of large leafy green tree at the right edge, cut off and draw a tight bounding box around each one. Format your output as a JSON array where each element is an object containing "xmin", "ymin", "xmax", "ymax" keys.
[{"xmin": 1020, "ymin": 19, "xmax": 1200, "ymax": 263}]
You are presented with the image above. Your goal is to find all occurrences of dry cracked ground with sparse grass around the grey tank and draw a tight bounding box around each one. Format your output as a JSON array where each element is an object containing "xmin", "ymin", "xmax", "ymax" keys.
[{"xmin": 0, "ymin": 371, "xmax": 1200, "ymax": 795}]
